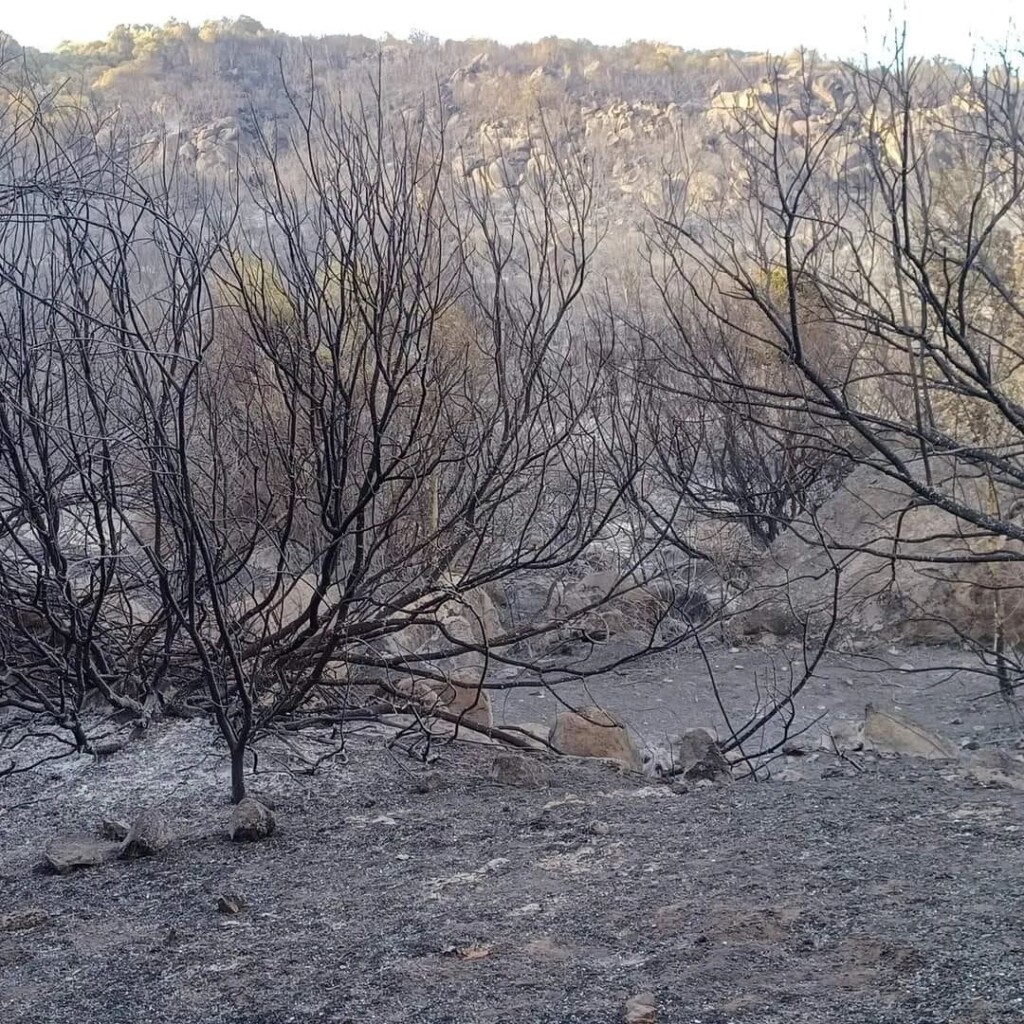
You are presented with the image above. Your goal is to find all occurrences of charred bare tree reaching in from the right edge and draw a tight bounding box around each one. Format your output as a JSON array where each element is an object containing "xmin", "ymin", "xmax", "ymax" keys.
[{"xmin": 651, "ymin": 41, "xmax": 1024, "ymax": 693}]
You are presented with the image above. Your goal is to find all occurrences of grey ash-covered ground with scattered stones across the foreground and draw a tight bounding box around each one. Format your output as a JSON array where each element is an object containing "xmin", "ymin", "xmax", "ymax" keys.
[{"xmin": 0, "ymin": 649, "xmax": 1024, "ymax": 1024}]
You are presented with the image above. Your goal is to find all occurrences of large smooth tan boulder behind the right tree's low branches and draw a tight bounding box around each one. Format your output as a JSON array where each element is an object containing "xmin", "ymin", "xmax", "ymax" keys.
[{"xmin": 731, "ymin": 457, "xmax": 1024, "ymax": 644}]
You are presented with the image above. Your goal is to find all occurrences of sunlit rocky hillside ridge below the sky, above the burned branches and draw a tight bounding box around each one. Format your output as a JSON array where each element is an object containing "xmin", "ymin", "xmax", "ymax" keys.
[{"xmin": 5, "ymin": 17, "xmax": 972, "ymax": 224}]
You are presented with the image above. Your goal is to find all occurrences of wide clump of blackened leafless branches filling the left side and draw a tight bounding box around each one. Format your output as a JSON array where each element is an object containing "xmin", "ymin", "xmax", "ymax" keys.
[{"xmin": 0, "ymin": 68, "xmax": 696, "ymax": 801}]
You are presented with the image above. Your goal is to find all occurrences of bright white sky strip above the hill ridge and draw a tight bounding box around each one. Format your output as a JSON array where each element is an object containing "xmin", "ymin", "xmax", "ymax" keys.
[{"xmin": 0, "ymin": 0, "xmax": 1024, "ymax": 63}]
